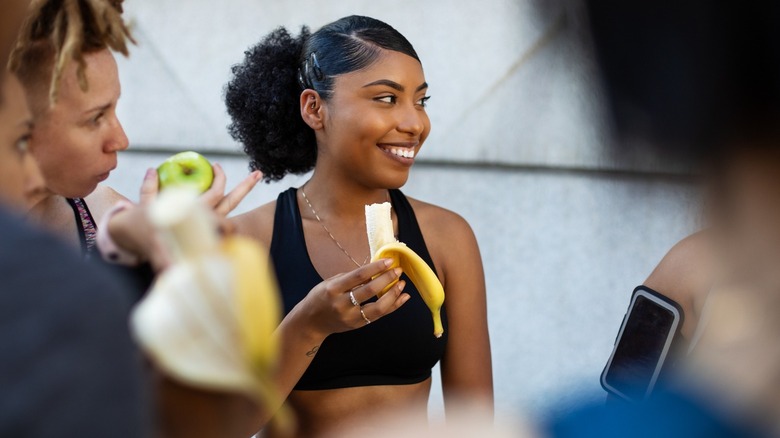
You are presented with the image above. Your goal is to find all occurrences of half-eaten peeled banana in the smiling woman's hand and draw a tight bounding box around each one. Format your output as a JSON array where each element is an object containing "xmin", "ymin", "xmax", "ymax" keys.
[{"xmin": 366, "ymin": 202, "xmax": 444, "ymax": 338}]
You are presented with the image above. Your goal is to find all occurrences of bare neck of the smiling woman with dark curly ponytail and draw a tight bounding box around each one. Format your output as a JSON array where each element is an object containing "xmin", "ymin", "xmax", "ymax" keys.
[{"xmin": 304, "ymin": 169, "xmax": 390, "ymax": 220}]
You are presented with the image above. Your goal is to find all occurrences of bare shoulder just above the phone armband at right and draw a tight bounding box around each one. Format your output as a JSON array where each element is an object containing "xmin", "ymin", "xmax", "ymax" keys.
[{"xmin": 645, "ymin": 230, "xmax": 714, "ymax": 307}]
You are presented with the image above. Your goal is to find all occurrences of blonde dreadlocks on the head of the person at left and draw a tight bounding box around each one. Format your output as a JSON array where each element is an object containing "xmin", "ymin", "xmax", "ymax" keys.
[{"xmin": 9, "ymin": 0, "xmax": 135, "ymax": 105}]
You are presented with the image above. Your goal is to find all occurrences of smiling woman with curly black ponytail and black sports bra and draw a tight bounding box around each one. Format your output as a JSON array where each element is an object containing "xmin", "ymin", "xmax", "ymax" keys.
[{"xmin": 226, "ymin": 16, "xmax": 493, "ymax": 436}]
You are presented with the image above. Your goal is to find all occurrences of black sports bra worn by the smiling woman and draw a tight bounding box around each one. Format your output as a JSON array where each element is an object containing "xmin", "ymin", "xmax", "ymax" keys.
[{"xmin": 271, "ymin": 188, "xmax": 447, "ymax": 390}]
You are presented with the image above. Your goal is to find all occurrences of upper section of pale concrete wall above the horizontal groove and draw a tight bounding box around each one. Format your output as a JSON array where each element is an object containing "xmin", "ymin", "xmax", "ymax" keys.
[{"xmin": 120, "ymin": 0, "xmax": 684, "ymax": 170}]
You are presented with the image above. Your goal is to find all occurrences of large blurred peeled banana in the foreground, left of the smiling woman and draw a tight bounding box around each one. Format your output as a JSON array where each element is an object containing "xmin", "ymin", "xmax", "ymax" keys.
[{"xmin": 130, "ymin": 188, "xmax": 290, "ymax": 424}]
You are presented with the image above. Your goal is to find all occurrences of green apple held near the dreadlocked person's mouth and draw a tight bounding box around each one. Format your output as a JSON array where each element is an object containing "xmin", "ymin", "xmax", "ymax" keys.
[{"xmin": 157, "ymin": 151, "xmax": 214, "ymax": 193}]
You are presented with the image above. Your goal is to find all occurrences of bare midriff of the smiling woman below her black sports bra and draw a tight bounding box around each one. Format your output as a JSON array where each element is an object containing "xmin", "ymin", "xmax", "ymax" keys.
[{"xmin": 261, "ymin": 378, "xmax": 431, "ymax": 438}]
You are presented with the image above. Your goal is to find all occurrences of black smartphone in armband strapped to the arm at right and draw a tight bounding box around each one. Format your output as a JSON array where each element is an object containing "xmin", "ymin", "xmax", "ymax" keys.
[{"xmin": 601, "ymin": 286, "xmax": 683, "ymax": 401}]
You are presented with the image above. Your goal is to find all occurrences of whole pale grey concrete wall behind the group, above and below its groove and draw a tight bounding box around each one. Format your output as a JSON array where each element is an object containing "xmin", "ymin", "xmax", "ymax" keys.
[{"xmin": 108, "ymin": 0, "xmax": 698, "ymax": 420}]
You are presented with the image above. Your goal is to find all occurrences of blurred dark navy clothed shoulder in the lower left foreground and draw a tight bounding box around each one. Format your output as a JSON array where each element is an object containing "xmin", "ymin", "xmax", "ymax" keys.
[{"xmin": 0, "ymin": 208, "xmax": 149, "ymax": 437}]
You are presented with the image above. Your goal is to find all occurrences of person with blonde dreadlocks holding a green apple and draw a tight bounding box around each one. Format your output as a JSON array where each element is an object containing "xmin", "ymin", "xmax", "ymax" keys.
[{"xmin": 10, "ymin": 0, "xmax": 259, "ymax": 282}]
